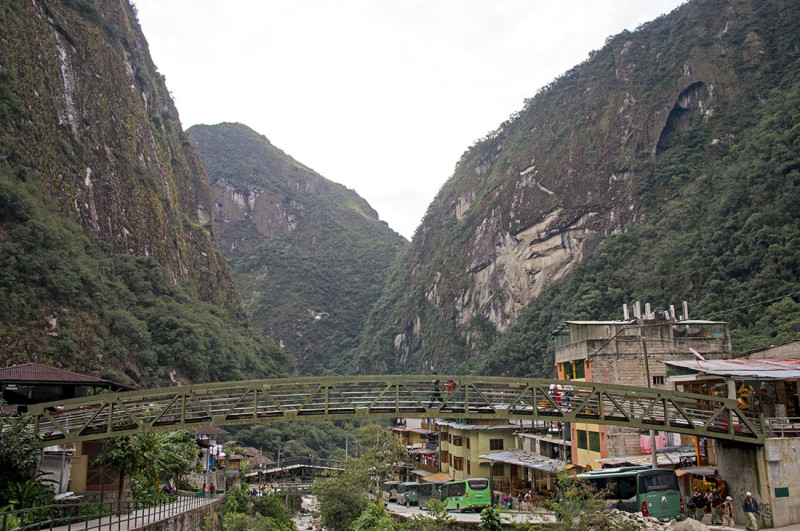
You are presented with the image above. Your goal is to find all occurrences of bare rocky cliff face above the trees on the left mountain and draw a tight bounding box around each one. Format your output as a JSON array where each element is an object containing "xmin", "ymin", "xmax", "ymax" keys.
[{"xmin": 0, "ymin": 0, "xmax": 239, "ymax": 307}]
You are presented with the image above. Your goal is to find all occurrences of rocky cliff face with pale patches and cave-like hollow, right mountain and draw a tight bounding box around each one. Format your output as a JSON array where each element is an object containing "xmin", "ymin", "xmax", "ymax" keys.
[{"xmin": 362, "ymin": 1, "xmax": 796, "ymax": 371}]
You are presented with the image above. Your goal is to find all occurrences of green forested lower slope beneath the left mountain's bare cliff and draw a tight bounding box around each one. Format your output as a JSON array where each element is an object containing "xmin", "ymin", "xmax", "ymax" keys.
[{"xmin": 0, "ymin": 172, "xmax": 291, "ymax": 386}]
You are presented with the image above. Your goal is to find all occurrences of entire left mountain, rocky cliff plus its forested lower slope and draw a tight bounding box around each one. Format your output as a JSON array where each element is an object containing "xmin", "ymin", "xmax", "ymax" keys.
[{"xmin": 0, "ymin": 0, "xmax": 287, "ymax": 385}]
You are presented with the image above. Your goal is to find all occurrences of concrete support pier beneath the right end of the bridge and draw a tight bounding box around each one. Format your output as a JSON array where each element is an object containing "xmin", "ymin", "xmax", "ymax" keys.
[{"xmin": 714, "ymin": 437, "xmax": 800, "ymax": 527}]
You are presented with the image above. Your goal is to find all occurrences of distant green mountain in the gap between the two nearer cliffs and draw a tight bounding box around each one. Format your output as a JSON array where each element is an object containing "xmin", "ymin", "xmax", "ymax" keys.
[{"xmin": 187, "ymin": 124, "xmax": 407, "ymax": 374}]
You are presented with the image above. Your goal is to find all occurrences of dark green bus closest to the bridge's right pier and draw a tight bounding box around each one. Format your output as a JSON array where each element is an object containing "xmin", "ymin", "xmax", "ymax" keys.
[{"xmin": 578, "ymin": 466, "xmax": 687, "ymax": 521}]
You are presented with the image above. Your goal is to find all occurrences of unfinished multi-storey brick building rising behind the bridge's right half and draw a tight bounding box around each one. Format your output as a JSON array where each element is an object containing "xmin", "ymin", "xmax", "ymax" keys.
[{"xmin": 553, "ymin": 303, "xmax": 732, "ymax": 468}]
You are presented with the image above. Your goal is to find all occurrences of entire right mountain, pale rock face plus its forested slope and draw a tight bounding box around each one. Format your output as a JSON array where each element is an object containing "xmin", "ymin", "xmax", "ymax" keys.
[{"xmin": 359, "ymin": 0, "xmax": 800, "ymax": 375}]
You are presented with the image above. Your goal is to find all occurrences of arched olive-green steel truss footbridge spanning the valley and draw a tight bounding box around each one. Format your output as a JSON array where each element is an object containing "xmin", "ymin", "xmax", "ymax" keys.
[{"xmin": 29, "ymin": 375, "xmax": 764, "ymax": 446}]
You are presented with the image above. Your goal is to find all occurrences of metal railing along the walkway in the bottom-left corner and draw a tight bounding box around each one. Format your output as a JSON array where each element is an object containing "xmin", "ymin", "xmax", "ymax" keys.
[{"xmin": 0, "ymin": 493, "xmax": 221, "ymax": 531}]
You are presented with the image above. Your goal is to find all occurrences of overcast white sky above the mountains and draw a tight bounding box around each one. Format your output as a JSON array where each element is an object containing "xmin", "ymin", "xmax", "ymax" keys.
[{"xmin": 134, "ymin": 0, "xmax": 684, "ymax": 239}]
